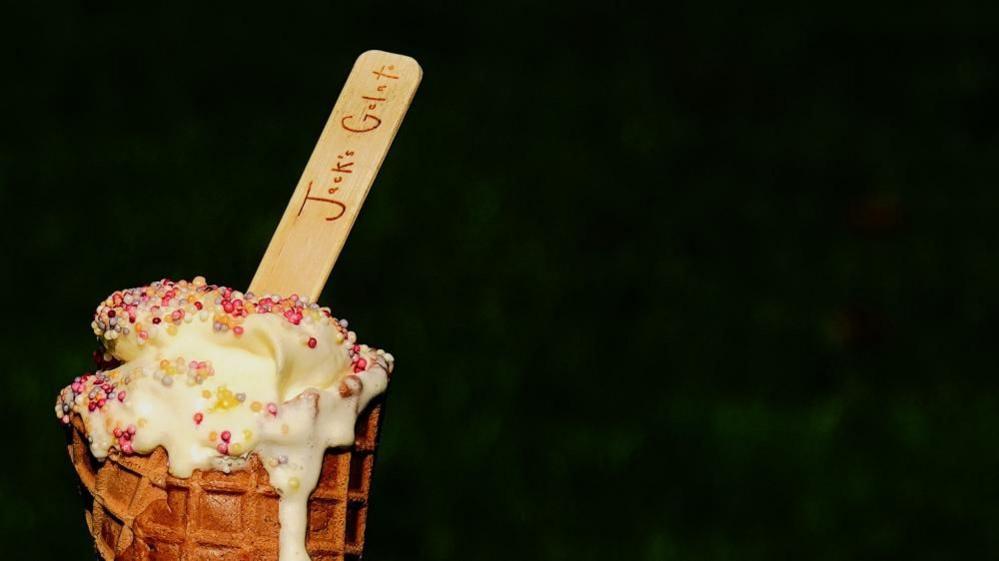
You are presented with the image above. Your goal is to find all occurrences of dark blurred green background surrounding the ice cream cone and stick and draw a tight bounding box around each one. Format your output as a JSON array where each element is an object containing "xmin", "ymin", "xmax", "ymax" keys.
[{"xmin": 0, "ymin": 2, "xmax": 999, "ymax": 560}]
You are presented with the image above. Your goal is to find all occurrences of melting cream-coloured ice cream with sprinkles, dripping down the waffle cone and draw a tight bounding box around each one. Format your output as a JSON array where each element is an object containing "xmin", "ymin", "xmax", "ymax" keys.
[{"xmin": 55, "ymin": 277, "xmax": 393, "ymax": 561}]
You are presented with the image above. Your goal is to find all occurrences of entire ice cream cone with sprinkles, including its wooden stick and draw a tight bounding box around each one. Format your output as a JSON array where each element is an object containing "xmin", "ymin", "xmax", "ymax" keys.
[{"xmin": 53, "ymin": 51, "xmax": 422, "ymax": 561}]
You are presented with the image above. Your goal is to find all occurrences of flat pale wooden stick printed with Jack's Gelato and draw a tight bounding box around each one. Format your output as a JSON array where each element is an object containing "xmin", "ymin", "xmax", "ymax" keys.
[{"xmin": 250, "ymin": 51, "xmax": 423, "ymax": 301}]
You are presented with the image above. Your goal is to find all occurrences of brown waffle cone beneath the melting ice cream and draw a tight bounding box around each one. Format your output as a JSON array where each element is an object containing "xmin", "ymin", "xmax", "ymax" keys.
[{"xmin": 68, "ymin": 401, "xmax": 382, "ymax": 561}]
